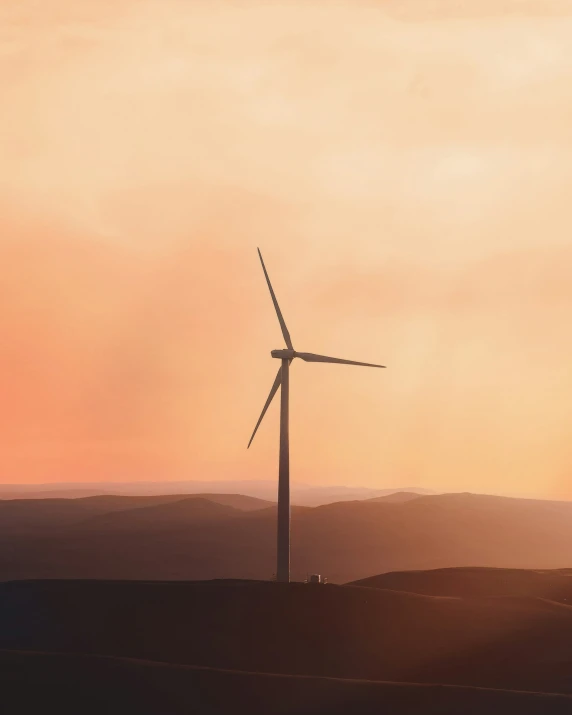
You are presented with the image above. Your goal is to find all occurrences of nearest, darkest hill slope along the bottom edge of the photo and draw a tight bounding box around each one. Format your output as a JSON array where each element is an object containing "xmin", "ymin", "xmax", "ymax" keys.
[{"xmin": 0, "ymin": 651, "xmax": 572, "ymax": 715}]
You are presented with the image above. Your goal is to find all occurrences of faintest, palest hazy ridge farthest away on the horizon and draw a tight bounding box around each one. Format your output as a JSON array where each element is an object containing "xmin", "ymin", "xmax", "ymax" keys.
[{"xmin": 0, "ymin": 480, "xmax": 434, "ymax": 506}]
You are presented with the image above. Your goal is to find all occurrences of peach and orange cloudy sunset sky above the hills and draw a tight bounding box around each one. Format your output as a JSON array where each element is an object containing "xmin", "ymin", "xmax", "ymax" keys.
[{"xmin": 0, "ymin": 0, "xmax": 572, "ymax": 498}]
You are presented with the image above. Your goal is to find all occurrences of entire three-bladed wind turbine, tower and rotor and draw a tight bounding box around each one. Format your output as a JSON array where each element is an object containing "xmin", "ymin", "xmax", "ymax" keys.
[{"xmin": 247, "ymin": 249, "xmax": 385, "ymax": 582}]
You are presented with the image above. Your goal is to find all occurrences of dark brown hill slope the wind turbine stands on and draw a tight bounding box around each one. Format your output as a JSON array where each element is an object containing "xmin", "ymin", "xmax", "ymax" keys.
[{"xmin": 5, "ymin": 581, "xmax": 572, "ymax": 694}]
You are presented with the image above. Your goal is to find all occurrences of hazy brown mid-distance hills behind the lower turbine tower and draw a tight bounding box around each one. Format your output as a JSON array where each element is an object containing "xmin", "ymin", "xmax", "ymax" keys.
[{"xmin": 0, "ymin": 494, "xmax": 572, "ymax": 583}]
